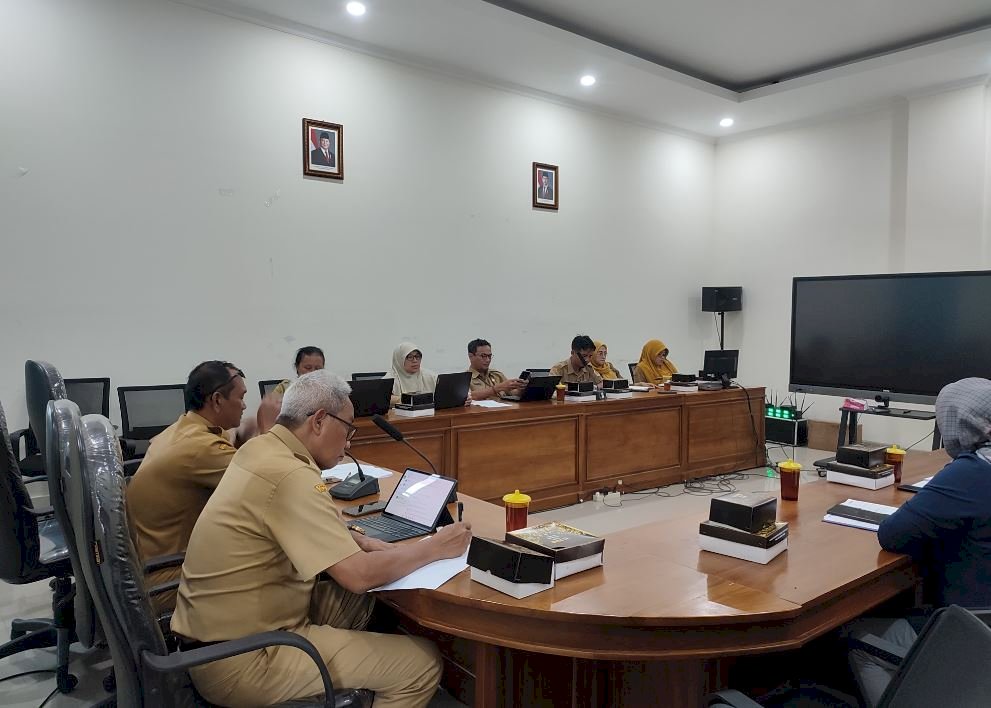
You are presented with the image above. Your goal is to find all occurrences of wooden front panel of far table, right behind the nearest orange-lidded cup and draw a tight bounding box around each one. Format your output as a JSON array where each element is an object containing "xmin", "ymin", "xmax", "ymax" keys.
[{"xmin": 453, "ymin": 418, "xmax": 578, "ymax": 499}]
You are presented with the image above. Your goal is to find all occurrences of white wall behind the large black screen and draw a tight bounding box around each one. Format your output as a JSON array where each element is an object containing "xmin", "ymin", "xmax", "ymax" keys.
[{"xmin": 714, "ymin": 85, "xmax": 991, "ymax": 444}]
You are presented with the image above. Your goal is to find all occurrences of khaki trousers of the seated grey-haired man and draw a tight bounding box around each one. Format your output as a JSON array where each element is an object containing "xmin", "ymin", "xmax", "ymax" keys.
[{"xmin": 190, "ymin": 580, "xmax": 441, "ymax": 708}]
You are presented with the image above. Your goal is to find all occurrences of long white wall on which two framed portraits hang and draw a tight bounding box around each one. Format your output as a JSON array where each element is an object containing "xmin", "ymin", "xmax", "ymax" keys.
[{"xmin": 0, "ymin": 0, "xmax": 714, "ymax": 427}]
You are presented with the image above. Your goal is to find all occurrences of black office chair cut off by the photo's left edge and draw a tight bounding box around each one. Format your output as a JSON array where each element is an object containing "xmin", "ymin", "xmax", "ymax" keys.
[{"xmin": 0, "ymin": 406, "xmax": 76, "ymax": 693}]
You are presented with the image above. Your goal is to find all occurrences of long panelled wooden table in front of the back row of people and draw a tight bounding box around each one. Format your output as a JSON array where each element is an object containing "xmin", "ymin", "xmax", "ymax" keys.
[{"xmin": 351, "ymin": 388, "xmax": 764, "ymax": 510}]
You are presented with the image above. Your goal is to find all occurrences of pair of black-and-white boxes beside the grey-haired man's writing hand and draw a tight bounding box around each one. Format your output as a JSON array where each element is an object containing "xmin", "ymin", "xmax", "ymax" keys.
[{"xmin": 468, "ymin": 521, "xmax": 606, "ymax": 598}]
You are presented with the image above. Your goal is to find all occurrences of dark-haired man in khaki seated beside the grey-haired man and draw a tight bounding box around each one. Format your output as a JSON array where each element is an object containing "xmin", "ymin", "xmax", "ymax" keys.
[{"xmin": 127, "ymin": 361, "xmax": 266, "ymax": 610}]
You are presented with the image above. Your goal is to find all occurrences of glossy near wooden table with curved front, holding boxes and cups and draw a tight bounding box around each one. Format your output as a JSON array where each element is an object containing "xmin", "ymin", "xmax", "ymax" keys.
[{"xmin": 346, "ymin": 450, "xmax": 948, "ymax": 706}]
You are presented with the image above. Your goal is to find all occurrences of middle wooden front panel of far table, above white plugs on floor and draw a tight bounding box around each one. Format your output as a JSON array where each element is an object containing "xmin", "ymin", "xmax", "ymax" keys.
[{"xmin": 585, "ymin": 407, "xmax": 682, "ymax": 481}]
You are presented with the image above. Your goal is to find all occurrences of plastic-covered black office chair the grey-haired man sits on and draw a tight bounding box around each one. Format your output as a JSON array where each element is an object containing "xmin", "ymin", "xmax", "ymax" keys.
[{"xmin": 76, "ymin": 415, "xmax": 374, "ymax": 708}]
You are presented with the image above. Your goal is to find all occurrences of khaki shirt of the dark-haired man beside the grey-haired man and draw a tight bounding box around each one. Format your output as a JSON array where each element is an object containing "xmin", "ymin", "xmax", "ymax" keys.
[{"xmin": 127, "ymin": 411, "xmax": 235, "ymax": 568}]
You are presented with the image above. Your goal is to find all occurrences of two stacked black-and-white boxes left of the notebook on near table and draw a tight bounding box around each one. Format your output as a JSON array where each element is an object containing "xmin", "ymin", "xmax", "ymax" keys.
[{"xmin": 699, "ymin": 492, "xmax": 788, "ymax": 565}]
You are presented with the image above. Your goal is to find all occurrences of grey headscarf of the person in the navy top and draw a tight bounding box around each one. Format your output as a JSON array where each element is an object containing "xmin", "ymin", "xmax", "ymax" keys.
[{"xmin": 936, "ymin": 378, "xmax": 991, "ymax": 461}]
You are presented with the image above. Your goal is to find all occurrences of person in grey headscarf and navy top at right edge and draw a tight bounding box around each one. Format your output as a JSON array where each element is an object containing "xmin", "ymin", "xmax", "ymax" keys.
[{"xmin": 850, "ymin": 378, "xmax": 991, "ymax": 706}]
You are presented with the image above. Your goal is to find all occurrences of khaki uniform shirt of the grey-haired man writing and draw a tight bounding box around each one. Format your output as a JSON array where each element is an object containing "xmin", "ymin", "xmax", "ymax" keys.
[{"xmin": 172, "ymin": 425, "xmax": 360, "ymax": 641}]
